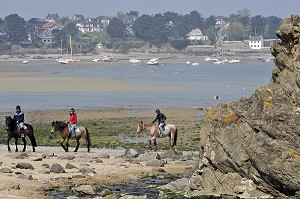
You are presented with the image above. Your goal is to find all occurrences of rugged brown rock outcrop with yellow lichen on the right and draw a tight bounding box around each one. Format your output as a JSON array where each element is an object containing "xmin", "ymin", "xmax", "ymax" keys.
[{"xmin": 188, "ymin": 16, "xmax": 300, "ymax": 198}]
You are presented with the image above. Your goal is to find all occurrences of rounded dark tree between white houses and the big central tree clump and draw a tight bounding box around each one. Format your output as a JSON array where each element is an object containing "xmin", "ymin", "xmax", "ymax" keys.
[{"xmin": 107, "ymin": 17, "xmax": 126, "ymax": 38}]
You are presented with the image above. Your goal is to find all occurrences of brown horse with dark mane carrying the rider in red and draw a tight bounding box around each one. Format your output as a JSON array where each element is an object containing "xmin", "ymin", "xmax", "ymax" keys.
[{"xmin": 51, "ymin": 121, "xmax": 91, "ymax": 152}]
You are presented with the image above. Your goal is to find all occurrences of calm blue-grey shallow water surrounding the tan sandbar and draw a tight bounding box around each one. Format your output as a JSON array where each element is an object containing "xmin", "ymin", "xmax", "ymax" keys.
[{"xmin": 0, "ymin": 61, "xmax": 274, "ymax": 111}]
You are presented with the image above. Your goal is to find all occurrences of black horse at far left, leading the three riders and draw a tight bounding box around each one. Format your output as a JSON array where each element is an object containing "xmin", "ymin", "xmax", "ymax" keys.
[{"xmin": 5, "ymin": 116, "xmax": 37, "ymax": 152}]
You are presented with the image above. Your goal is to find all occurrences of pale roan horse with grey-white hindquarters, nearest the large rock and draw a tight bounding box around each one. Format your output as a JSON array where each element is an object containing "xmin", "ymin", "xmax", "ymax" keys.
[{"xmin": 136, "ymin": 121, "xmax": 178, "ymax": 151}]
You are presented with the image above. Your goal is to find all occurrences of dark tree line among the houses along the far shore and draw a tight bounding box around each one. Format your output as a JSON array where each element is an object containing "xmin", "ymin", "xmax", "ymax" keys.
[{"xmin": 0, "ymin": 9, "xmax": 282, "ymax": 50}]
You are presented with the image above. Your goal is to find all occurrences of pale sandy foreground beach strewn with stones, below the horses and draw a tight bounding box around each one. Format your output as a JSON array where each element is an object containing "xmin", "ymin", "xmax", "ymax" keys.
[{"xmin": 0, "ymin": 145, "xmax": 198, "ymax": 199}]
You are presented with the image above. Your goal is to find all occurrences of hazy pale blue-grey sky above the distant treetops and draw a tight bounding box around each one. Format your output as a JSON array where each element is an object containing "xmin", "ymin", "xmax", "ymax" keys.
[{"xmin": 0, "ymin": 0, "xmax": 300, "ymax": 20}]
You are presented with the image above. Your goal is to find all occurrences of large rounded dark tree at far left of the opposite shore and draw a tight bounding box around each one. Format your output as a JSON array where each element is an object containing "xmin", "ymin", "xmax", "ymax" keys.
[{"xmin": 2, "ymin": 14, "xmax": 28, "ymax": 44}]
